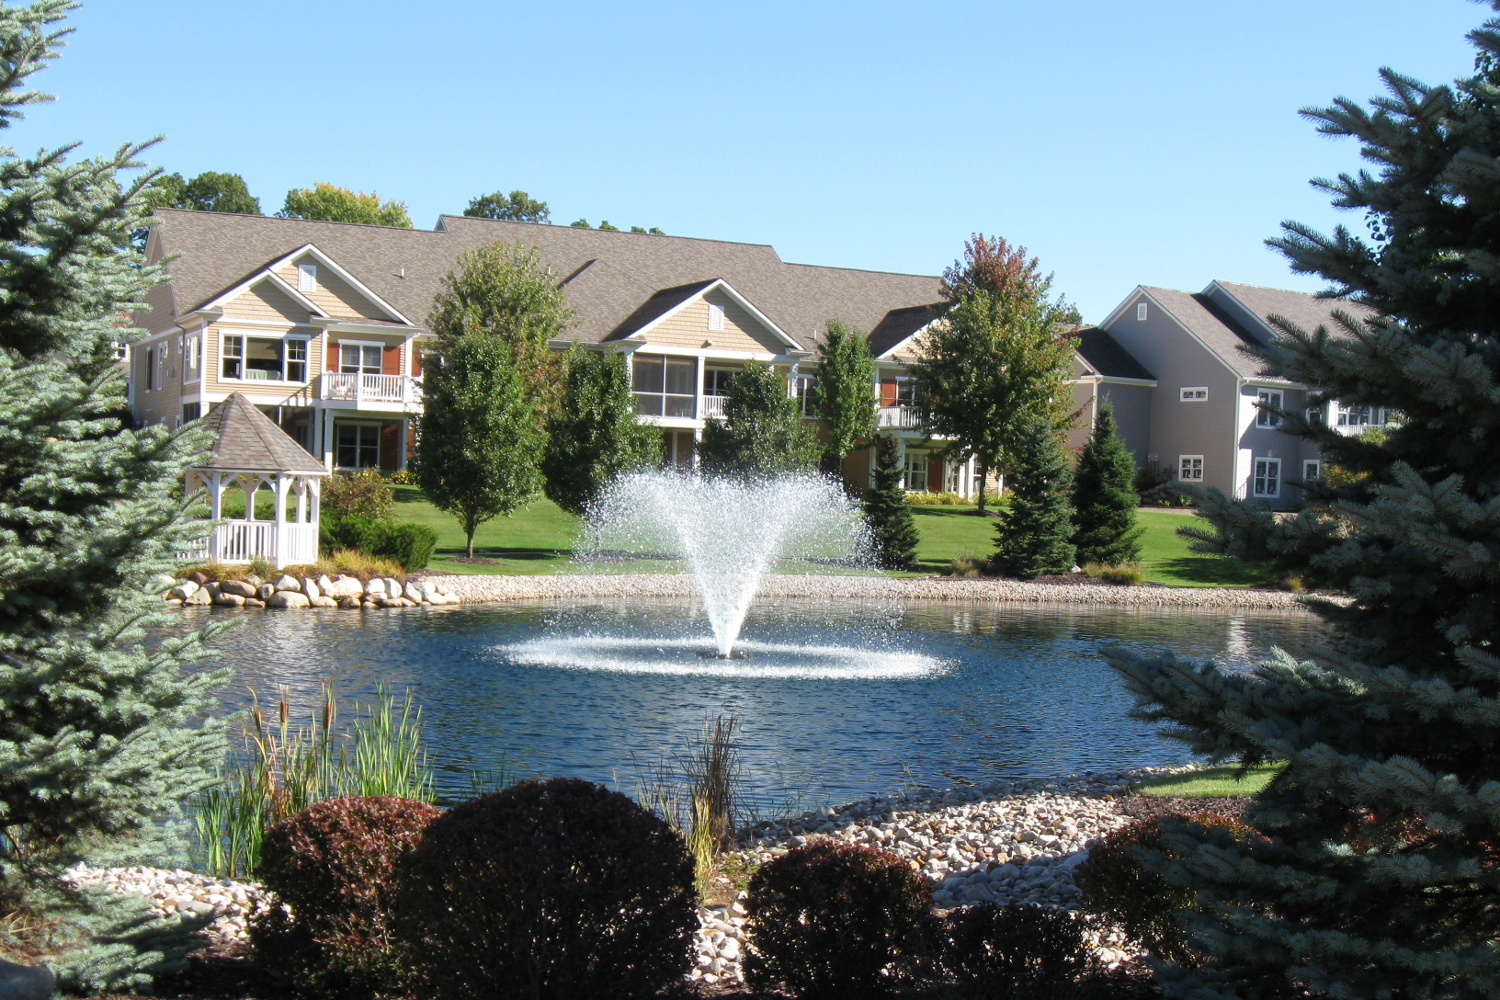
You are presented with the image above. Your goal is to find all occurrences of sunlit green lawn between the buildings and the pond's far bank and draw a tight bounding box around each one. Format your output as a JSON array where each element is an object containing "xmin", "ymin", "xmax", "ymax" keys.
[{"xmin": 393, "ymin": 486, "xmax": 1269, "ymax": 586}]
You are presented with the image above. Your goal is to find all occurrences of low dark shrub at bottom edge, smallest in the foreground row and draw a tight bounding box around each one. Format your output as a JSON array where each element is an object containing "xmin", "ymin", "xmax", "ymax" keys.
[{"xmin": 941, "ymin": 903, "xmax": 1097, "ymax": 1000}]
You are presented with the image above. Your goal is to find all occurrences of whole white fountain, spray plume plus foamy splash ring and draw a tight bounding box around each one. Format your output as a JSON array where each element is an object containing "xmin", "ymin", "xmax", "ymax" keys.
[{"xmin": 503, "ymin": 471, "xmax": 944, "ymax": 679}]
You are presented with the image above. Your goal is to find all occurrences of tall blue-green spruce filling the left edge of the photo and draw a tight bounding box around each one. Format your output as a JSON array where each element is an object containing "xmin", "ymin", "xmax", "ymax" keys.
[{"xmin": 0, "ymin": 0, "xmax": 224, "ymax": 993}]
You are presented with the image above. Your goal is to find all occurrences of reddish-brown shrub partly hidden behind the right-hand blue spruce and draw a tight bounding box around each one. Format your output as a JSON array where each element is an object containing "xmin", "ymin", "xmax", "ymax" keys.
[{"xmin": 1074, "ymin": 813, "xmax": 1254, "ymax": 963}]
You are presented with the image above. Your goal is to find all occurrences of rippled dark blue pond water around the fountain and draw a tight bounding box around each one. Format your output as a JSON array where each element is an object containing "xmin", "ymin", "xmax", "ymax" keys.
[{"xmin": 170, "ymin": 600, "xmax": 1325, "ymax": 810}]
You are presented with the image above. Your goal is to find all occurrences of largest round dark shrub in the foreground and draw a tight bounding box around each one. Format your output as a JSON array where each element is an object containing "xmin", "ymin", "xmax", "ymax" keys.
[{"xmin": 396, "ymin": 778, "xmax": 698, "ymax": 1000}]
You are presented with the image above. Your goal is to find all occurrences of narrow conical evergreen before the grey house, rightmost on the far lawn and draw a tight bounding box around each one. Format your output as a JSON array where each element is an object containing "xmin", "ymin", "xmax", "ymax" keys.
[{"xmin": 1073, "ymin": 402, "xmax": 1145, "ymax": 565}]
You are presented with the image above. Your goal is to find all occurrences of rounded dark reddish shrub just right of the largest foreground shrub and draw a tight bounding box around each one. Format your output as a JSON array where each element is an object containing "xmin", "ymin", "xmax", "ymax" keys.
[{"xmin": 743, "ymin": 841, "xmax": 932, "ymax": 997}]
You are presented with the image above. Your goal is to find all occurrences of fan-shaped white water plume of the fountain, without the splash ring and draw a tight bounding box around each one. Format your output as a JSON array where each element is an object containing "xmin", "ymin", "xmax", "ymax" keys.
[{"xmin": 588, "ymin": 471, "xmax": 867, "ymax": 657}]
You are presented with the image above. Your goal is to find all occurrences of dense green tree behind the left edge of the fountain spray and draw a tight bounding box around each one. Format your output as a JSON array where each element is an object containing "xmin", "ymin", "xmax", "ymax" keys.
[{"xmin": 542, "ymin": 348, "xmax": 662, "ymax": 514}]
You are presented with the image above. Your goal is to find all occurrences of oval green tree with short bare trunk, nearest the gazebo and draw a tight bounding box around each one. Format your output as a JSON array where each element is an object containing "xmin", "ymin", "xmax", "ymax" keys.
[{"xmin": 417, "ymin": 336, "xmax": 545, "ymax": 559}]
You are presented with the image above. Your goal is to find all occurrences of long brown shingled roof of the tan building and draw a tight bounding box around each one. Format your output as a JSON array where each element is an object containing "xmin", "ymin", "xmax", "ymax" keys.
[{"xmin": 140, "ymin": 208, "xmax": 942, "ymax": 349}]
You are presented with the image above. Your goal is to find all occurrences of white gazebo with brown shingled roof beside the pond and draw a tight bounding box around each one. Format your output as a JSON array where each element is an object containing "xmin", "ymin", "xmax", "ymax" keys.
[{"xmin": 186, "ymin": 393, "xmax": 329, "ymax": 570}]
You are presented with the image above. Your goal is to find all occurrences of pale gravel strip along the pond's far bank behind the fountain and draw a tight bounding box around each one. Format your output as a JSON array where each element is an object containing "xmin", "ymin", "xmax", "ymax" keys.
[{"xmin": 425, "ymin": 573, "xmax": 1338, "ymax": 610}]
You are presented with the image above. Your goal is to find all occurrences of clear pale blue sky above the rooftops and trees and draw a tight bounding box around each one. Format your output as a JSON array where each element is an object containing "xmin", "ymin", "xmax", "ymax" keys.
[{"xmin": 23, "ymin": 0, "xmax": 1490, "ymax": 321}]
